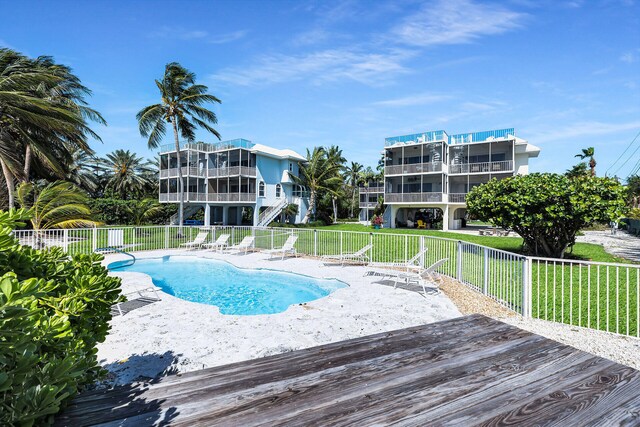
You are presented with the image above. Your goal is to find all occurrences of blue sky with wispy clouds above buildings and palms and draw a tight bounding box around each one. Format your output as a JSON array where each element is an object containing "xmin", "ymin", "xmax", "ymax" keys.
[{"xmin": 0, "ymin": 0, "xmax": 640, "ymax": 177}]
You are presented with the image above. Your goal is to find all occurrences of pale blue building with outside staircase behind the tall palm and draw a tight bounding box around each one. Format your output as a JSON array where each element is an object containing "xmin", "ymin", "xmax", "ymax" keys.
[{"xmin": 159, "ymin": 139, "xmax": 309, "ymax": 226}]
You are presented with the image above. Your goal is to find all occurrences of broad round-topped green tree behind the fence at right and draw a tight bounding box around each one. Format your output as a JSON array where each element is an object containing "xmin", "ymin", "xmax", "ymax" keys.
[{"xmin": 467, "ymin": 173, "xmax": 626, "ymax": 258}]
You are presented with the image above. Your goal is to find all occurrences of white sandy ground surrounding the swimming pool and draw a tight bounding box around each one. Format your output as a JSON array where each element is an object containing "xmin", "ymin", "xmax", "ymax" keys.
[{"xmin": 98, "ymin": 251, "xmax": 460, "ymax": 385}]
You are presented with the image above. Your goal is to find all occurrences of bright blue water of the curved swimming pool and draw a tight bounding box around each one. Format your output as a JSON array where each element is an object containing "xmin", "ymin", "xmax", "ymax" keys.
[{"xmin": 109, "ymin": 256, "xmax": 347, "ymax": 315}]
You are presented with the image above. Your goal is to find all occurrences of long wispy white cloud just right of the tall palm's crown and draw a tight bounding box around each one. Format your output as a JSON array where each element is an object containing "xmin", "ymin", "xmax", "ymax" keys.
[{"xmin": 212, "ymin": 49, "xmax": 413, "ymax": 86}]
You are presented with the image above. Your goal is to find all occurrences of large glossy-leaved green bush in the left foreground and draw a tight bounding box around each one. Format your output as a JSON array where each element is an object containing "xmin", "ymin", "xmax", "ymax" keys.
[{"xmin": 0, "ymin": 209, "xmax": 122, "ymax": 426}]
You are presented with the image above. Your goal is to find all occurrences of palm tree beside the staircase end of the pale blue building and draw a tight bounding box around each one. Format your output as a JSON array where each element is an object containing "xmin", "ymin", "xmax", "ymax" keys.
[{"xmin": 291, "ymin": 147, "xmax": 342, "ymax": 224}]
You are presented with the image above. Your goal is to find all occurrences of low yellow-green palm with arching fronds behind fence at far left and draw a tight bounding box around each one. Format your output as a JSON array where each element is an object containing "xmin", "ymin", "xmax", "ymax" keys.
[{"xmin": 16, "ymin": 181, "xmax": 99, "ymax": 247}]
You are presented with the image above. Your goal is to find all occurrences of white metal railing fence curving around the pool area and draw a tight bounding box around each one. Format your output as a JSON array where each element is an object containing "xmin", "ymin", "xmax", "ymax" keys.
[{"xmin": 14, "ymin": 226, "xmax": 640, "ymax": 337}]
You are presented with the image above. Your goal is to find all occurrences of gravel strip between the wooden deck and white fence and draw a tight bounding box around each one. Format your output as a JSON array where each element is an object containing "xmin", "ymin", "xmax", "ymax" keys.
[{"xmin": 440, "ymin": 278, "xmax": 640, "ymax": 370}]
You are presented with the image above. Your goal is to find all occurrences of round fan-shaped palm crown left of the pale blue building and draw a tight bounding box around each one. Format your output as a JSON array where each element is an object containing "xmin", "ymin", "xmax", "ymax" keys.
[{"xmin": 98, "ymin": 150, "xmax": 156, "ymax": 199}]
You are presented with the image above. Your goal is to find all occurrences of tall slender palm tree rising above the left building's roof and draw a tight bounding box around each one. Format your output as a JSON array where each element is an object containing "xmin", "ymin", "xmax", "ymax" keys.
[{"xmin": 136, "ymin": 62, "xmax": 222, "ymax": 234}]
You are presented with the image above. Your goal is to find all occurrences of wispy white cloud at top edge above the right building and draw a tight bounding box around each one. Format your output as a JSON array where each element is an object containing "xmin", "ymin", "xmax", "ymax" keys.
[{"xmin": 391, "ymin": 0, "xmax": 527, "ymax": 46}]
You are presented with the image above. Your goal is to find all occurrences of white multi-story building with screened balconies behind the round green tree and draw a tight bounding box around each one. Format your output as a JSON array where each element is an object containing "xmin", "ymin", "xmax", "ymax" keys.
[{"xmin": 361, "ymin": 128, "xmax": 540, "ymax": 230}]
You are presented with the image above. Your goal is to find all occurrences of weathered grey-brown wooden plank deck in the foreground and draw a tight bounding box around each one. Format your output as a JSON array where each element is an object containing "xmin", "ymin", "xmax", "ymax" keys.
[{"xmin": 57, "ymin": 315, "xmax": 640, "ymax": 426}]
